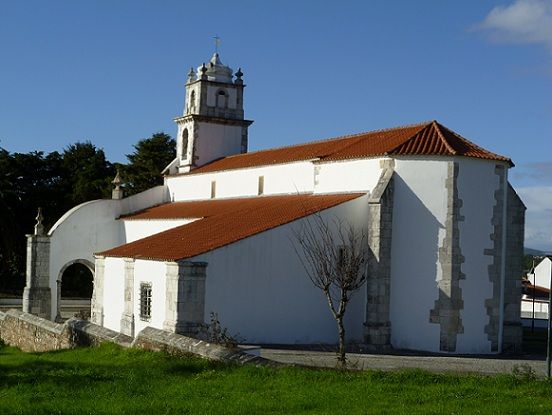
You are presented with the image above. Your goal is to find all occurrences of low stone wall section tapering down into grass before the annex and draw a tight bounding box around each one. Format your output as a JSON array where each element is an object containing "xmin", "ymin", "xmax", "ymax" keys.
[{"xmin": 132, "ymin": 327, "xmax": 285, "ymax": 367}]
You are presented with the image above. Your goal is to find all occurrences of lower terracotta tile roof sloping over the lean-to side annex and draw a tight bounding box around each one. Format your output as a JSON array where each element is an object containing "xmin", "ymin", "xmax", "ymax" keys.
[{"xmin": 97, "ymin": 193, "xmax": 364, "ymax": 261}]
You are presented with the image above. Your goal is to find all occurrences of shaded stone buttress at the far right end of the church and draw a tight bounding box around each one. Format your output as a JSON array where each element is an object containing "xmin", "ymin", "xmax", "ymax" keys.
[{"xmin": 502, "ymin": 184, "xmax": 526, "ymax": 352}]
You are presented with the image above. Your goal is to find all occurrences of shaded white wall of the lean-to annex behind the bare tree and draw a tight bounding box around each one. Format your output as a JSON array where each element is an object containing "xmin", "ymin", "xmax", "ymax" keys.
[{"xmin": 190, "ymin": 196, "xmax": 368, "ymax": 344}]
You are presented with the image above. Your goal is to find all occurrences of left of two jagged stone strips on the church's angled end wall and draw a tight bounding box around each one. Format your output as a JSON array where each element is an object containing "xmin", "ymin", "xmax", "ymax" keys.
[{"xmin": 429, "ymin": 162, "xmax": 466, "ymax": 352}]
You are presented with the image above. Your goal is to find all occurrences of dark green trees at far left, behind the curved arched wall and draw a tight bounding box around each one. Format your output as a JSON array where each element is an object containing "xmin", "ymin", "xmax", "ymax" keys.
[{"xmin": 0, "ymin": 142, "xmax": 115, "ymax": 293}]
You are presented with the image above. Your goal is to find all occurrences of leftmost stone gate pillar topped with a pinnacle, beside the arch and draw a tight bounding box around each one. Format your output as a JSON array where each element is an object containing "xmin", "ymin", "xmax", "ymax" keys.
[{"xmin": 23, "ymin": 208, "xmax": 52, "ymax": 320}]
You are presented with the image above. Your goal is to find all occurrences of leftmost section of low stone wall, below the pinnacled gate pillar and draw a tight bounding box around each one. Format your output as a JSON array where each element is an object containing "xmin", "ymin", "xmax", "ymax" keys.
[{"xmin": 0, "ymin": 310, "xmax": 74, "ymax": 352}]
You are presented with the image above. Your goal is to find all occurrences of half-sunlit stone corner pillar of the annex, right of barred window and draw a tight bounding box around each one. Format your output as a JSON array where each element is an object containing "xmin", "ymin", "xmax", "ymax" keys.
[{"xmin": 163, "ymin": 262, "xmax": 207, "ymax": 335}]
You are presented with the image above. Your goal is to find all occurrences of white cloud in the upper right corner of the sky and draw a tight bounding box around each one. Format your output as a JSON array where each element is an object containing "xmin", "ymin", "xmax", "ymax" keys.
[{"xmin": 476, "ymin": 0, "xmax": 552, "ymax": 52}]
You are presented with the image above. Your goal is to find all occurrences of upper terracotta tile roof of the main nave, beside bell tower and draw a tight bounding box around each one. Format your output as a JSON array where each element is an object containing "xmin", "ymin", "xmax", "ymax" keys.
[{"xmin": 186, "ymin": 121, "xmax": 513, "ymax": 174}]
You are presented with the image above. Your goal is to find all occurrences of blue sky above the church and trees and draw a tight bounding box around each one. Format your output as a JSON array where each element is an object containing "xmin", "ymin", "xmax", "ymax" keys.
[{"xmin": 0, "ymin": 0, "xmax": 552, "ymax": 251}]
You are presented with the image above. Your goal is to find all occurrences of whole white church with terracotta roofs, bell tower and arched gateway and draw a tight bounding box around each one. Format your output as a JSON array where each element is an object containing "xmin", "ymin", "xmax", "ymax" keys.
[{"xmin": 24, "ymin": 54, "xmax": 525, "ymax": 353}]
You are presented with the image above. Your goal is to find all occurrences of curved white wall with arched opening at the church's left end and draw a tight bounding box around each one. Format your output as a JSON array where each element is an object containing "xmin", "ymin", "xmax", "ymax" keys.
[{"xmin": 45, "ymin": 186, "xmax": 168, "ymax": 316}]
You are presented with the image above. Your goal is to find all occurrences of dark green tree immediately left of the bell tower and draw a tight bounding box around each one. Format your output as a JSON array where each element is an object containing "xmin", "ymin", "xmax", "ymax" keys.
[{"xmin": 121, "ymin": 132, "xmax": 176, "ymax": 195}]
